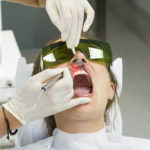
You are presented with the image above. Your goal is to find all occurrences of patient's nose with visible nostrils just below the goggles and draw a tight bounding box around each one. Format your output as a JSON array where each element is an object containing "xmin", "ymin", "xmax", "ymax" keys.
[{"xmin": 71, "ymin": 51, "xmax": 88, "ymax": 67}]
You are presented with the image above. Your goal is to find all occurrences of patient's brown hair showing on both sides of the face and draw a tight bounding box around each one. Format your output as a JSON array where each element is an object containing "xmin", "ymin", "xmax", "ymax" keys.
[{"xmin": 32, "ymin": 38, "xmax": 119, "ymax": 136}]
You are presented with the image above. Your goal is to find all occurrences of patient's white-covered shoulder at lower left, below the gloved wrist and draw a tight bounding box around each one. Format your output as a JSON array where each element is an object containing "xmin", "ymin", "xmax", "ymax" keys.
[{"xmin": 19, "ymin": 136, "xmax": 53, "ymax": 150}]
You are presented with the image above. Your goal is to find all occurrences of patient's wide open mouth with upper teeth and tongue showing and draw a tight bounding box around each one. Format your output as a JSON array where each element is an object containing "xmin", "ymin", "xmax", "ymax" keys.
[{"xmin": 73, "ymin": 70, "xmax": 93, "ymax": 97}]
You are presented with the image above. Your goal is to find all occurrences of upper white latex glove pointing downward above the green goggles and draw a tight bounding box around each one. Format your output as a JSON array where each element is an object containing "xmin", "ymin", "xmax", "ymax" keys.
[{"xmin": 46, "ymin": 0, "xmax": 94, "ymax": 48}]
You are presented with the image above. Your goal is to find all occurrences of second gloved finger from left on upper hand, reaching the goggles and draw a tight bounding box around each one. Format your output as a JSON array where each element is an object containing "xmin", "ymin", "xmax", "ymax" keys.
[{"xmin": 66, "ymin": 6, "xmax": 78, "ymax": 48}]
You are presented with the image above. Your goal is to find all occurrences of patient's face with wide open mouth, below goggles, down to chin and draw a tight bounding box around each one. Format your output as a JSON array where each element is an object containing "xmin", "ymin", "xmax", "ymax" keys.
[{"xmin": 52, "ymin": 39, "xmax": 114, "ymax": 122}]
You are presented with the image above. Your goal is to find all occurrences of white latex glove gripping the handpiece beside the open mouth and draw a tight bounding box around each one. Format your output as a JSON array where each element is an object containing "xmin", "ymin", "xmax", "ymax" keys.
[{"xmin": 3, "ymin": 68, "xmax": 90, "ymax": 124}]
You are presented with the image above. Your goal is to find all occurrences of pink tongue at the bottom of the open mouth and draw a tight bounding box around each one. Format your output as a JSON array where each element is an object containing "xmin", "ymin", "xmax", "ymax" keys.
[{"xmin": 74, "ymin": 87, "xmax": 90, "ymax": 97}]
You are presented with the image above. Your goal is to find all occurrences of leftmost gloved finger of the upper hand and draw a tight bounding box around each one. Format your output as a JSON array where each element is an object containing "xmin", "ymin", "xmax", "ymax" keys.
[{"xmin": 61, "ymin": 7, "xmax": 72, "ymax": 41}]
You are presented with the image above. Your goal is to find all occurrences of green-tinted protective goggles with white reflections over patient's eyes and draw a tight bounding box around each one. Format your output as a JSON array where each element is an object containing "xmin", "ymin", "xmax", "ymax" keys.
[{"xmin": 41, "ymin": 39, "xmax": 112, "ymax": 70}]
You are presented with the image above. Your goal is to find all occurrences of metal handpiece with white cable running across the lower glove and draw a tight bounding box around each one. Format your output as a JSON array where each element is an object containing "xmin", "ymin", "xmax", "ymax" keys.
[{"xmin": 14, "ymin": 73, "xmax": 63, "ymax": 150}]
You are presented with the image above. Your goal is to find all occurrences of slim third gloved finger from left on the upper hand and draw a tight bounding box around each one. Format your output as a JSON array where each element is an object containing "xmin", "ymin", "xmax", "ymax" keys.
[{"xmin": 74, "ymin": 8, "xmax": 84, "ymax": 47}]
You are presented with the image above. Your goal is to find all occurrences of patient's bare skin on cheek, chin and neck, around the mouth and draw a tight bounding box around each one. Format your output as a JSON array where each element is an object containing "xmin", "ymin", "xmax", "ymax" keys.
[{"xmin": 51, "ymin": 40, "xmax": 115, "ymax": 133}]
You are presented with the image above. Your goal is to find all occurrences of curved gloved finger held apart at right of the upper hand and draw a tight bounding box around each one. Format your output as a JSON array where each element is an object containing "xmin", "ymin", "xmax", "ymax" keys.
[{"xmin": 83, "ymin": 1, "xmax": 95, "ymax": 32}]
